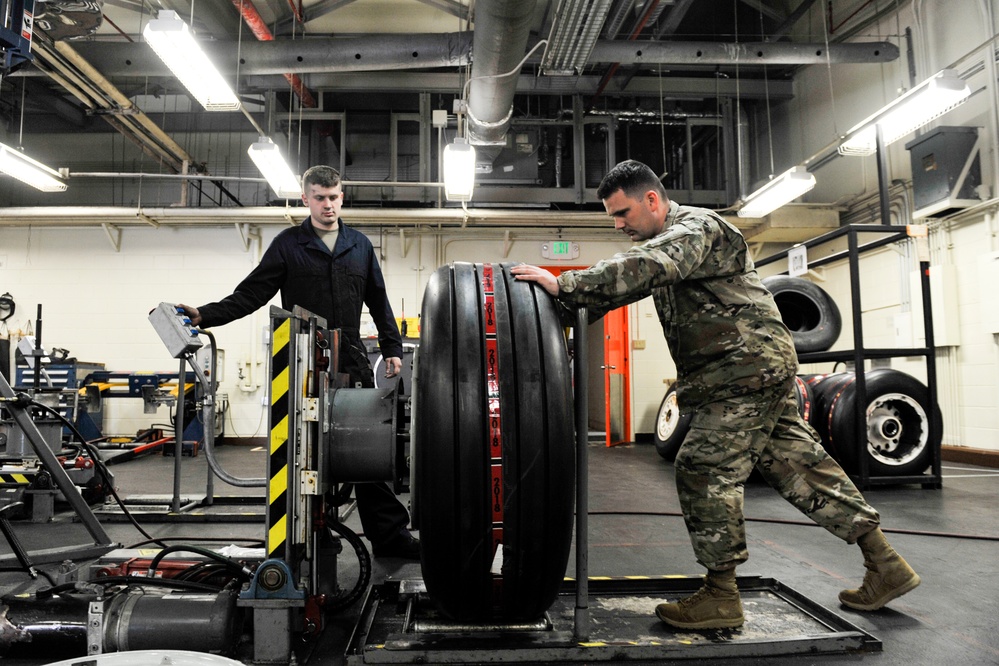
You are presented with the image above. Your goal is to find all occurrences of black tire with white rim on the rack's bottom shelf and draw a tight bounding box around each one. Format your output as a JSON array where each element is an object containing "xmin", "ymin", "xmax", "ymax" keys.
[{"xmin": 829, "ymin": 368, "xmax": 943, "ymax": 476}]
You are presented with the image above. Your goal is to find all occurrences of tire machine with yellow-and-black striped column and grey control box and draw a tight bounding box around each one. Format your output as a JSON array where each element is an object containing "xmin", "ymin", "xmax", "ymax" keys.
[{"xmin": 150, "ymin": 304, "xmax": 409, "ymax": 664}]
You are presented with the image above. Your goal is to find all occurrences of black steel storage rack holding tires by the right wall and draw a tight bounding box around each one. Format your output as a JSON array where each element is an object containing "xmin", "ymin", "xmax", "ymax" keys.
[{"xmin": 756, "ymin": 224, "xmax": 943, "ymax": 490}]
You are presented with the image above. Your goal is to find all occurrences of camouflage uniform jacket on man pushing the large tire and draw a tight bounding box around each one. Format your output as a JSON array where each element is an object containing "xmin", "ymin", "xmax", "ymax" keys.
[{"xmin": 559, "ymin": 201, "xmax": 797, "ymax": 409}]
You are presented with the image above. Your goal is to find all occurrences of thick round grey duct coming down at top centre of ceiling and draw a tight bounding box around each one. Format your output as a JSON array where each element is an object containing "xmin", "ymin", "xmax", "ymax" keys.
[{"xmin": 467, "ymin": 0, "xmax": 537, "ymax": 146}]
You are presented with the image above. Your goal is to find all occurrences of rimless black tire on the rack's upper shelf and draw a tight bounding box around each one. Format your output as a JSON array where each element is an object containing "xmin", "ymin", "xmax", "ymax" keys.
[{"xmin": 763, "ymin": 275, "xmax": 843, "ymax": 354}]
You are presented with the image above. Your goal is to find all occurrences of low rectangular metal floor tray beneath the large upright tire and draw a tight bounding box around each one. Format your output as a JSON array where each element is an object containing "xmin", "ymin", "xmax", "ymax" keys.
[{"xmin": 345, "ymin": 576, "xmax": 881, "ymax": 666}]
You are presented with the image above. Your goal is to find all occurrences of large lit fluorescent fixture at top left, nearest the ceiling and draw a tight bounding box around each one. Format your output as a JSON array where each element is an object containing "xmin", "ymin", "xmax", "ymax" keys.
[{"xmin": 142, "ymin": 9, "xmax": 240, "ymax": 111}]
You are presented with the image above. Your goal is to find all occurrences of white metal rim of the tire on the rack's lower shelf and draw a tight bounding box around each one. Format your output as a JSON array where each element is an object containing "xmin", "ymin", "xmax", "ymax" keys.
[{"xmin": 867, "ymin": 393, "xmax": 929, "ymax": 466}]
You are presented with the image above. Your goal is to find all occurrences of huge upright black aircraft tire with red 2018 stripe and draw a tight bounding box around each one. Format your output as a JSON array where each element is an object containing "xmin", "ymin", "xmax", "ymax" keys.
[{"xmin": 413, "ymin": 263, "xmax": 575, "ymax": 622}]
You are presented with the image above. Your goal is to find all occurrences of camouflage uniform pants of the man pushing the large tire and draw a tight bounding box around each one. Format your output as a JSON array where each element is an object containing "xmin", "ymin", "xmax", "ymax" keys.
[{"xmin": 676, "ymin": 380, "xmax": 880, "ymax": 570}]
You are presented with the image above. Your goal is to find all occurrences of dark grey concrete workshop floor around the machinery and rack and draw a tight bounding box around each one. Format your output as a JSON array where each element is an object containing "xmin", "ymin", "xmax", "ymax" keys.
[{"xmin": 0, "ymin": 444, "xmax": 999, "ymax": 666}]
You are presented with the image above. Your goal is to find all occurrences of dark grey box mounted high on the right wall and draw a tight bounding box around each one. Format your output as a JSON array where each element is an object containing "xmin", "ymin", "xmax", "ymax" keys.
[{"xmin": 905, "ymin": 127, "xmax": 982, "ymax": 218}]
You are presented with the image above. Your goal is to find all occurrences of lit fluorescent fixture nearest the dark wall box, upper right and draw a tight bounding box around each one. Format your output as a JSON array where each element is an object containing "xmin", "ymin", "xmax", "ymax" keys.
[{"xmin": 839, "ymin": 69, "xmax": 971, "ymax": 155}]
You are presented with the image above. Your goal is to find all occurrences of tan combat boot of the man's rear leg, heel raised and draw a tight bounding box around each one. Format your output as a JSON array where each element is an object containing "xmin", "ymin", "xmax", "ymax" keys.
[{"xmin": 839, "ymin": 528, "xmax": 919, "ymax": 610}]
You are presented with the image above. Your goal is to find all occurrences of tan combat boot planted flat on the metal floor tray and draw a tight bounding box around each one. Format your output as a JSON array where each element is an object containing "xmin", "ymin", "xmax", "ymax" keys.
[{"xmin": 656, "ymin": 569, "xmax": 744, "ymax": 629}]
